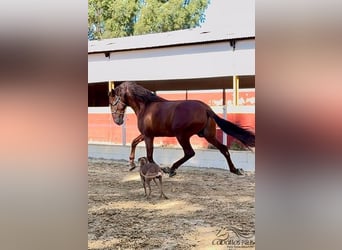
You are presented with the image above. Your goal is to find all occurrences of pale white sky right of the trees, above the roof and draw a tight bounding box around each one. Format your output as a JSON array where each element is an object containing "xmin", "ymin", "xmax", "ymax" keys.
[{"xmin": 202, "ymin": 0, "xmax": 255, "ymax": 32}]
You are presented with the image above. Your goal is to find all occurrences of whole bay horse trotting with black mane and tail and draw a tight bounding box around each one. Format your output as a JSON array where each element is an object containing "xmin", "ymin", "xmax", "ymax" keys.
[{"xmin": 108, "ymin": 81, "xmax": 255, "ymax": 177}]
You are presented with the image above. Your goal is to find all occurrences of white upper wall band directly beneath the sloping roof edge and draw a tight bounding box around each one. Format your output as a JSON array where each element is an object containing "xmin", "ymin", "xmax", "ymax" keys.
[{"xmin": 88, "ymin": 39, "xmax": 255, "ymax": 83}]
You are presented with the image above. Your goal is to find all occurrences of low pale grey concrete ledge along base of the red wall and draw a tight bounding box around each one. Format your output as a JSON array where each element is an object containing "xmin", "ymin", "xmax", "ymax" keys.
[{"xmin": 88, "ymin": 144, "xmax": 255, "ymax": 171}]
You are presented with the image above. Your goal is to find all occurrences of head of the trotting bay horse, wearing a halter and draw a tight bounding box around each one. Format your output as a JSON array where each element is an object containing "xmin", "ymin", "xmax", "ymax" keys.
[{"xmin": 108, "ymin": 86, "xmax": 127, "ymax": 125}]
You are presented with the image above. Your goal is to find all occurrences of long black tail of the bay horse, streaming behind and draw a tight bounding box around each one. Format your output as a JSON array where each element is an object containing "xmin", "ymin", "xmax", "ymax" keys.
[{"xmin": 208, "ymin": 110, "xmax": 255, "ymax": 147}]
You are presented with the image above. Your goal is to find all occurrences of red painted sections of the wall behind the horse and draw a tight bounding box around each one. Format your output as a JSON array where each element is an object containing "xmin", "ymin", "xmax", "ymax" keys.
[{"xmin": 88, "ymin": 90, "xmax": 255, "ymax": 148}]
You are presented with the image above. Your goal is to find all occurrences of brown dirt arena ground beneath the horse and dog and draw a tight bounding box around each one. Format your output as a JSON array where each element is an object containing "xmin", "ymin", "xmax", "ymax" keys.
[{"xmin": 88, "ymin": 159, "xmax": 255, "ymax": 250}]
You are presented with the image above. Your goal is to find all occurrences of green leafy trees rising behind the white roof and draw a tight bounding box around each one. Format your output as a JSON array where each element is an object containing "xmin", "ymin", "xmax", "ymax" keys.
[{"xmin": 88, "ymin": 0, "xmax": 210, "ymax": 39}]
